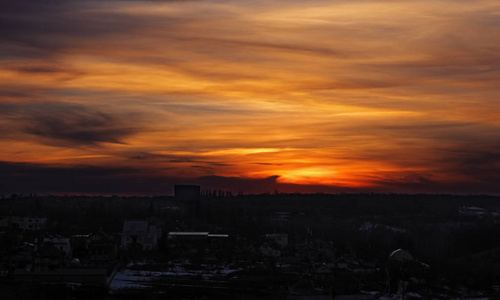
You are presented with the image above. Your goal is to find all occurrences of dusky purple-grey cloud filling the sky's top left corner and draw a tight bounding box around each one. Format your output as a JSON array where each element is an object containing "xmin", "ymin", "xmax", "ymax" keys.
[{"xmin": 0, "ymin": 0, "xmax": 209, "ymax": 60}]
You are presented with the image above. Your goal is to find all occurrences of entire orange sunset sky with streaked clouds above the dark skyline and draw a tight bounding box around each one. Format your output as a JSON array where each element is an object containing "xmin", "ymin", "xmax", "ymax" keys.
[{"xmin": 0, "ymin": 0, "xmax": 500, "ymax": 195}]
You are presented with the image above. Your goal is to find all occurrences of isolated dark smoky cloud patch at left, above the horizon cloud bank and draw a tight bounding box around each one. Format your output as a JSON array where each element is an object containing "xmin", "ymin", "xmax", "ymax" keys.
[{"xmin": 0, "ymin": 103, "xmax": 138, "ymax": 146}]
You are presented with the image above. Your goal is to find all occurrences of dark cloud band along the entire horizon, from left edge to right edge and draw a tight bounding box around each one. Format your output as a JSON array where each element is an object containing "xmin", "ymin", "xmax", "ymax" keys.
[{"xmin": 0, "ymin": 161, "xmax": 500, "ymax": 195}]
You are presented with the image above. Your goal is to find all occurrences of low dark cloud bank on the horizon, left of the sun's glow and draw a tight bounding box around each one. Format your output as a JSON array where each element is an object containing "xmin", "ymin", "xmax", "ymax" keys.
[{"xmin": 0, "ymin": 161, "xmax": 278, "ymax": 195}]
